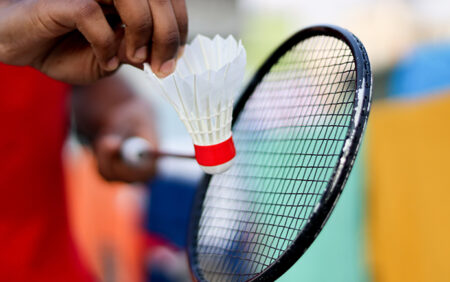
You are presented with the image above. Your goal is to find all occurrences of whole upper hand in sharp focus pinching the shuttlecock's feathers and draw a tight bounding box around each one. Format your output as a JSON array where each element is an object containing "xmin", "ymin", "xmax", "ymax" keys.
[{"xmin": 0, "ymin": 0, "xmax": 187, "ymax": 84}]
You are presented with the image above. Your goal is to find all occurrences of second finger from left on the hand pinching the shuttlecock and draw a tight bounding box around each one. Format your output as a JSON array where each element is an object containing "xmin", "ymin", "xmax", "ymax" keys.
[{"xmin": 111, "ymin": 0, "xmax": 152, "ymax": 64}]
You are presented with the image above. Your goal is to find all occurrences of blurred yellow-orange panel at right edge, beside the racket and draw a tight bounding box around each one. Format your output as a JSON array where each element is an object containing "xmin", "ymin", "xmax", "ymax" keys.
[{"xmin": 367, "ymin": 93, "xmax": 450, "ymax": 282}]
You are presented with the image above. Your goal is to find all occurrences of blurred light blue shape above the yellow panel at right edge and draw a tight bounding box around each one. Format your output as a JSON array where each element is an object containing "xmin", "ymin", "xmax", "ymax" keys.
[{"xmin": 388, "ymin": 42, "xmax": 450, "ymax": 98}]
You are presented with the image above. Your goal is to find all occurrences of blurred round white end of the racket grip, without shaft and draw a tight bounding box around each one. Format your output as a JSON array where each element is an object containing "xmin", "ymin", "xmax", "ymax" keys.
[{"xmin": 120, "ymin": 137, "xmax": 152, "ymax": 166}]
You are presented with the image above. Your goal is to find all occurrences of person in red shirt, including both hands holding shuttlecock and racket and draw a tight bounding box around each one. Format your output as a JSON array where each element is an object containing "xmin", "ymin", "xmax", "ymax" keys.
[{"xmin": 0, "ymin": 0, "xmax": 187, "ymax": 281}]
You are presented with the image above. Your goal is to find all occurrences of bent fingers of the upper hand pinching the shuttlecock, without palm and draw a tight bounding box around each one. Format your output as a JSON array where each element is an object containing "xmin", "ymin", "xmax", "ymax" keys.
[{"xmin": 76, "ymin": 0, "xmax": 188, "ymax": 77}]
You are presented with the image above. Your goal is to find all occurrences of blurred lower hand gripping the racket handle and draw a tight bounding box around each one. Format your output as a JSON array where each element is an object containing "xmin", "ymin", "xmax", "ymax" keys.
[{"xmin": 72, "ymin": 75, "xmax": 158, "ymax": 182}]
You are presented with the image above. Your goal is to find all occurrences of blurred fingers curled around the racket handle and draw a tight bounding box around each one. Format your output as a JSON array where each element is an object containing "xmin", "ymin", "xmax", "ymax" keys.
[{"xmin": 95, "ymin": 134, "xmax": 156, "ymax": 182}]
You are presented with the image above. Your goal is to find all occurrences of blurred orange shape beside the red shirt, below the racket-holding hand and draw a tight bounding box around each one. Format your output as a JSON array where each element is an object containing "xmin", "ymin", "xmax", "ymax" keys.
[{"xmin": 65, "ymin": 149, "xmax": 144, "ymax": 282}]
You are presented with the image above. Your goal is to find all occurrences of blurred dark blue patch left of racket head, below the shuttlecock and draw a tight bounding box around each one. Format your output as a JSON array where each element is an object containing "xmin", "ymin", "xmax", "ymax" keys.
[{"xmin": 146, "ymin": 177, "xmax": 197, "ymax": 248}]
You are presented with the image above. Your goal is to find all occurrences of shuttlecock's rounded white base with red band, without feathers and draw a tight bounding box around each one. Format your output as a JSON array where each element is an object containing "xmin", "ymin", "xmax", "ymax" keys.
[{"xmin": 194, "ymin": 137, "xmax": 236, "ymax": 174}]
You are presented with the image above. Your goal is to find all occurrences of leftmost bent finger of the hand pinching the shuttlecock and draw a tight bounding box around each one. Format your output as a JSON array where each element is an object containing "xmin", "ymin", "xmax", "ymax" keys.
[{"xmin": 74, "ymin": 0, "xmax": 119, "ymax": 71}]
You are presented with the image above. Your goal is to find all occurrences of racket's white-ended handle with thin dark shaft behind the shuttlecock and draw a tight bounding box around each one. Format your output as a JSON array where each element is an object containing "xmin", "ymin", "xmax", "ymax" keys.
[{"xmin": 120, "ymin": 137, "xmax": 195, "ymax": 166}]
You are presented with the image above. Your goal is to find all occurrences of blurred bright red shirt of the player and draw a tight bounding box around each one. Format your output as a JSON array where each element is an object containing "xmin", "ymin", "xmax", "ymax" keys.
[{"xmin": 0, "ymin": 64, "xmax": 91, "ymax": 282}]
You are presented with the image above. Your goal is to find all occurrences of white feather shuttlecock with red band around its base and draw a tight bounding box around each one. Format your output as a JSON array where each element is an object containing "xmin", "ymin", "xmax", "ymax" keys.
[{"xmin": 144, "ymin": 35, "xmax": 246, "ymax": 174}]
